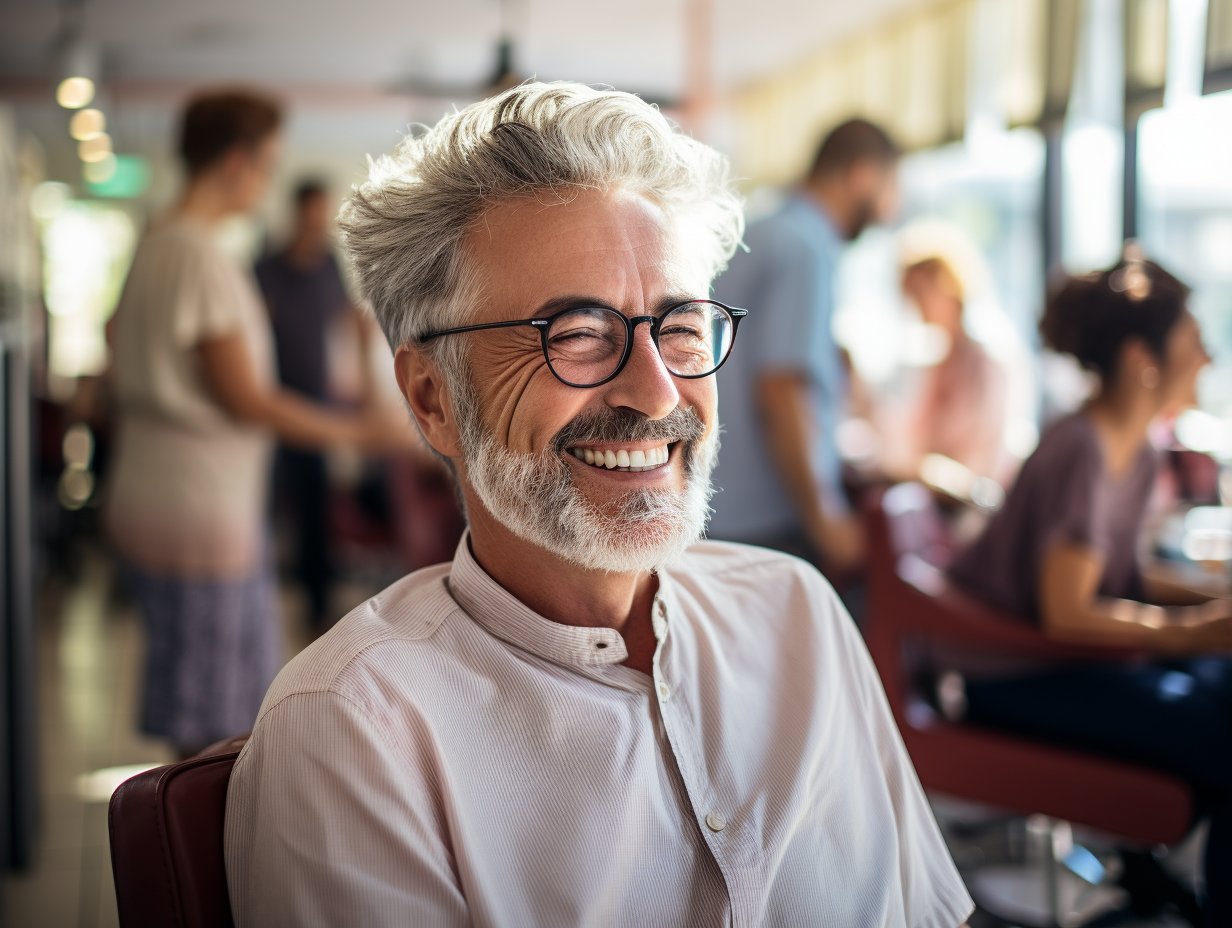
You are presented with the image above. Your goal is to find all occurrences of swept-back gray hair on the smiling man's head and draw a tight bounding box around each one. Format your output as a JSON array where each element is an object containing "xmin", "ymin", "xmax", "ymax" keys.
[{"xmin": 339, "ymin": 81, "xmax": 744, "ymax": 348}]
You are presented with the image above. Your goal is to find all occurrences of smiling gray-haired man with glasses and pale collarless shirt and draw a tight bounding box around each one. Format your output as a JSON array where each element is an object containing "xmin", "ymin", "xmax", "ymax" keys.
[{"xmin": 225, "ymin": 84, "xmax": 971, "ymax": 928}]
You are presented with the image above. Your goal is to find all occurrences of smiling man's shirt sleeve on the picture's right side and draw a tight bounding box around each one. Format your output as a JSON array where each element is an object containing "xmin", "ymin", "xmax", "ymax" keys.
[{"xmin": 823, "ymin": 579, "xmax": 975, "ymax": 928}]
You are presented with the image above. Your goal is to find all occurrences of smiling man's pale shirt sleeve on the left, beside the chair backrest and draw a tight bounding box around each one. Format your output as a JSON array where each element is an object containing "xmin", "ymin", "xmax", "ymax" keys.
[{"xmin": 225, "ymin": 693, "xmax": 468, "ymax": 928}]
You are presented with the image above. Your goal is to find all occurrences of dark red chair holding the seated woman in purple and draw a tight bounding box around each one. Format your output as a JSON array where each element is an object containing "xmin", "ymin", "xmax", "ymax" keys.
[{"xmin": 864, "ymin": 484, "xmax": 1194, "ymax": 844}]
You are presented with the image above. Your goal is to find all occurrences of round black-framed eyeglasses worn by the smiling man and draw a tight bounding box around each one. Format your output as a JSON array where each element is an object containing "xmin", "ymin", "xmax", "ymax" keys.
[{"xmin": 419, "ymin": 299, "xmax": 749, "ymax": 387}]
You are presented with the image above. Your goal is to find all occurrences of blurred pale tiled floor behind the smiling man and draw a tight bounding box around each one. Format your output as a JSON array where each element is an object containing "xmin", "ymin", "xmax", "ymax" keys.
[{"xmin": 2, "ymin": 548, "xmax": 1196, "ymax": 928}]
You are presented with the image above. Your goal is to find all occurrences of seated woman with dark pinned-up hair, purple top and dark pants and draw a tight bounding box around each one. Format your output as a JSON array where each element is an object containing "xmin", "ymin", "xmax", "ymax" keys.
[{"xmin": 950, "ymin": 253, "xmax": 1232, "ymax": 926}]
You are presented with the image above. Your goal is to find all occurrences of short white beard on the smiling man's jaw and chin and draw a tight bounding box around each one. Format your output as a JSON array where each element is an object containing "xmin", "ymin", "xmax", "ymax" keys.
[{"xmin": 460, "ymin": 415, "xmax": 718, "ymax": 573}]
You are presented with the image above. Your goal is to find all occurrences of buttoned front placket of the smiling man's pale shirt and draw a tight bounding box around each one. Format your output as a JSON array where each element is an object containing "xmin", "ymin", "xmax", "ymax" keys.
[{"xmin": 650, "ymin": 582, "xmax": 752, "ymax": 926}]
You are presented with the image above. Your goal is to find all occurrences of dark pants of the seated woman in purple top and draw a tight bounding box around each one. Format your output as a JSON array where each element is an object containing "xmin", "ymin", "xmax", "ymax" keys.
[{"xmin": 967, "ymin": 657, "xmax": 1232, "ymax": 928}]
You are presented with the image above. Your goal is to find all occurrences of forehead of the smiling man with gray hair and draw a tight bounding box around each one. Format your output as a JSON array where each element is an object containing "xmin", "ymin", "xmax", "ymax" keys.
[{"xmin": 467, "ymin": 190, "xmax": 705, "ymax": 315}]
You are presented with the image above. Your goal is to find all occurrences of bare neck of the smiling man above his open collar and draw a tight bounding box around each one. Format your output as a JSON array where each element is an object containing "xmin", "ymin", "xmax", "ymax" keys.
[{"xmin": 467, "ymin": 493, "xmax": 659, "ymax": 674}]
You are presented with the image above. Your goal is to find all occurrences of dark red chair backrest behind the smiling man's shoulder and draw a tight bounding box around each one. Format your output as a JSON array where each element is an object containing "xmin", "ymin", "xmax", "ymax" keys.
[{"xmin": 107, "ymin": 735, "xmax": 248, "ymax": 928}]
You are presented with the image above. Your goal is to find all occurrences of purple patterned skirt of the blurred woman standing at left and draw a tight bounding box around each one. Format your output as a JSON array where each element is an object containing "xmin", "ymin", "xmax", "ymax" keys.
[{"xmin": 126, "ymin": 564, "xmax": 282, "ymax": 752}]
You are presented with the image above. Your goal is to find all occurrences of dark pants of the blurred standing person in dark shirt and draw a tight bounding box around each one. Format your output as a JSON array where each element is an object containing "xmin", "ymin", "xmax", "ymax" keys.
[{"xmin": 277, "ymin": 449, "xmax": 333, "ymax": 627}]
